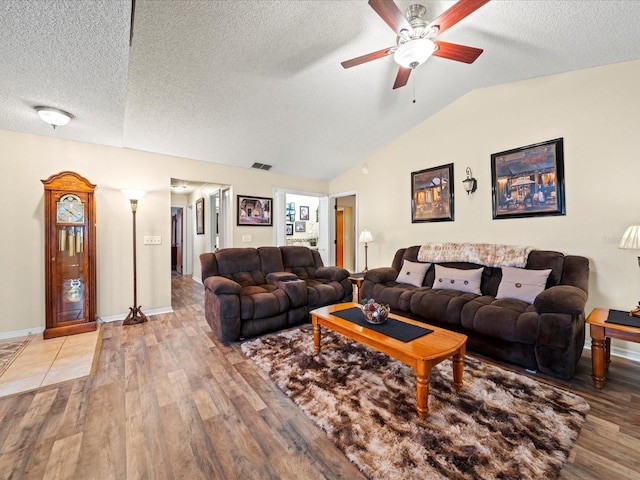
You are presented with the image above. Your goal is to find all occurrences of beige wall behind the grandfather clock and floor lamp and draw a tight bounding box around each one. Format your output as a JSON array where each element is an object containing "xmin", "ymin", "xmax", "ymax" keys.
[{"xmin": 0, "ymin": 130, "xmax": 328, "ymax": 336}]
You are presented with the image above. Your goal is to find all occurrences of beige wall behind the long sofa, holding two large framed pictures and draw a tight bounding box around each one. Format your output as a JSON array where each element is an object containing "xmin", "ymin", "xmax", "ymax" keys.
[{"xmin": 330, "ymin": 61, "xmax": 640, "ymax": 354}]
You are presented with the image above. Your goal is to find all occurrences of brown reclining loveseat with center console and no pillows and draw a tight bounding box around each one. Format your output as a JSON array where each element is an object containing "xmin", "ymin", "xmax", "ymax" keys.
[{"xmin": 200, "ymin": 246, "xmax": 353, "ymax": 341}]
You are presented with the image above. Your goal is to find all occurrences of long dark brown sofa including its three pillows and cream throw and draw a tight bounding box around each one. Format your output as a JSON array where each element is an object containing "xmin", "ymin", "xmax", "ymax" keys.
[{"xmin": 362, "ymin": 244, "xmax": 589, "ymax": 378}]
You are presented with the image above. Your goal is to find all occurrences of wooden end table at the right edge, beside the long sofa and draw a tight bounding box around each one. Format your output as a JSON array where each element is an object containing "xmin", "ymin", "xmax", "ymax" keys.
[{"xmin": 586, "ymin": 308, "xmax": 640, "ymax": 388}]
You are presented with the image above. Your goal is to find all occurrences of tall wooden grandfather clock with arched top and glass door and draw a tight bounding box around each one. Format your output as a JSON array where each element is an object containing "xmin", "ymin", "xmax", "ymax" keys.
[{"xmin": 42, "ymin": 172, "xmax": 96, "ymax": 338}]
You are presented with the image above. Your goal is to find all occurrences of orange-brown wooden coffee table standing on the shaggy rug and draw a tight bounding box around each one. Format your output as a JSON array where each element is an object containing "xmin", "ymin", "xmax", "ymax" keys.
[{"xmin": 311, "ymin": 303, "xmax": 467, "ymax": 418}]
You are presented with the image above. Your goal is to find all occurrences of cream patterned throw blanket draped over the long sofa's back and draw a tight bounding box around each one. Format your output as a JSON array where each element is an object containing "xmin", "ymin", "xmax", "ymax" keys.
[{"xmin": 418, "ymin": 242, "xmax": 533, "ymax": 268}]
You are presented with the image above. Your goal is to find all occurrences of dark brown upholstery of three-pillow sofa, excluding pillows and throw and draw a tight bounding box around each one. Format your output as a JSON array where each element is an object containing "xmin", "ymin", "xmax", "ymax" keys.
[{"xmin": 362, "ymin": 246, "xmax": 589, "ymax": 378}]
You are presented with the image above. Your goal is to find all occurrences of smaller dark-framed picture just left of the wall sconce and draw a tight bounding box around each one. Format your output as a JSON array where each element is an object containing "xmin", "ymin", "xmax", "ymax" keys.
[{"xmin": 411, "ymin": 163, "xmax": 454, "ymax": 223}]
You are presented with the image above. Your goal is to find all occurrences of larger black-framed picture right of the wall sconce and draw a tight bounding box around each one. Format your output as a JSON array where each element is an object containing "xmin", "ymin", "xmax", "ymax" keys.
[{"xmin": 491, "ymin": 138, "xmax": 565, "ymax": 219}]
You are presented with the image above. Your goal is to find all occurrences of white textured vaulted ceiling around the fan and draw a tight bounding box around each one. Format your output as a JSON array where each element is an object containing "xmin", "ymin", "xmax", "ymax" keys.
[{"xmin": 0, "ymin": 0, "xmax": 640, "ymax": 180}]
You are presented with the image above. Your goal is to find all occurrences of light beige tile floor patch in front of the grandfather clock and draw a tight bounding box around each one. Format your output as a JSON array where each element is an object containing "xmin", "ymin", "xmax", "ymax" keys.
[{"xmin": 0, "ymin": 325, "xmax": 102, "ymax": 397}]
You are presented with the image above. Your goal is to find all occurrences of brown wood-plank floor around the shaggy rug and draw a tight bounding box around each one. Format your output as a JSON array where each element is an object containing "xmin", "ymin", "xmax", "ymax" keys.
[{"xmin": 0, "ymin": 277, "xmax": 640, "ymax": 480}]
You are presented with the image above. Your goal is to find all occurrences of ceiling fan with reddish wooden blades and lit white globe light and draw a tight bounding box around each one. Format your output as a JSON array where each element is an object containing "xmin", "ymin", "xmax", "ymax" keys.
[{"xmin": 341, "ymin": 0, "xmax": 489, "ymax": 89}]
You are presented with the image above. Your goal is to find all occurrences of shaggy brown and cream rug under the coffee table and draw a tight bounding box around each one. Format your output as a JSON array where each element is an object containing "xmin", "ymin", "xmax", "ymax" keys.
[{"xmin": 242, "ymin": 325, "xmax": 589, "ymax": 479}]
